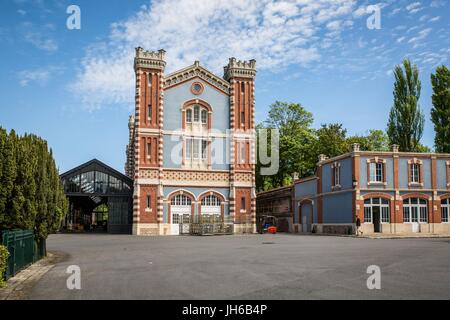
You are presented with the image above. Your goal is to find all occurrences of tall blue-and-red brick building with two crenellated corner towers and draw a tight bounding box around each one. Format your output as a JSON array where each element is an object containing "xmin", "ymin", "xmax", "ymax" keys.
[{"xmin": 125, "ymin": 48, "xmax": 256, "ymax": 235}]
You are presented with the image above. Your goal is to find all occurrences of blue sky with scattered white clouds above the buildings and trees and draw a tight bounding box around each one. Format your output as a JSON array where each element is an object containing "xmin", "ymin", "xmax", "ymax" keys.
[{"xmin": 0, "ymin": 0, "xmax": 450, "ymax": 171}]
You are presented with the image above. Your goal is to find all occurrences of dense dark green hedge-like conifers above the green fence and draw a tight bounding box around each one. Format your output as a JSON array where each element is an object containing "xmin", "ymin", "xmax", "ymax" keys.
[{"xmin": 0, "ymin": 128, "xmax": 68, "ymax": 240}]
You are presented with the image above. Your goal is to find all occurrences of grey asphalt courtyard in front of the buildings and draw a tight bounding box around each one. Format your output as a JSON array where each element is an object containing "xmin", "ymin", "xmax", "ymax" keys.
[{"xmin": 29, "ymin": 234, "xmax": 450, "ymax": 300}]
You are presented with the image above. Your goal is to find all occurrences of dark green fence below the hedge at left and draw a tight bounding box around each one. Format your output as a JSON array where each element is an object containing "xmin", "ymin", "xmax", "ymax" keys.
[{"xmin": 1, "ymin": 230, "xmax": 47, "ymax": 279}]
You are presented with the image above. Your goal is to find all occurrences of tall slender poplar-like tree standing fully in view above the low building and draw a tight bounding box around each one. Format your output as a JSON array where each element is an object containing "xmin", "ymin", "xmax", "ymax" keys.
[{"xmin": 387, "ymin": 59, "xmax": 425, "ymax": 151}]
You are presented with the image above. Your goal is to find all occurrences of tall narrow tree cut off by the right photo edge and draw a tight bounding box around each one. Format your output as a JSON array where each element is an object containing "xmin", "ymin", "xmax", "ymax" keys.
[{"xmin": 431, "ymin": 65, "xmax": 450, "ymax": 153}]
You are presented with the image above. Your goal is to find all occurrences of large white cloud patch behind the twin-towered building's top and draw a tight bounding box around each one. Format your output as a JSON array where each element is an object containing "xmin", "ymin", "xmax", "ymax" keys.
[{"xmin": 70, "ymin": 0, "xmax": 356, "ymax": 108}]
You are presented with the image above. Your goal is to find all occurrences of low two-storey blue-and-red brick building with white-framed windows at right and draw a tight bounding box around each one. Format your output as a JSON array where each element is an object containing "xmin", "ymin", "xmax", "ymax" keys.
[{"xmin": 258, "ymin": 144, "xmax": 450, "ymax": 234}]
